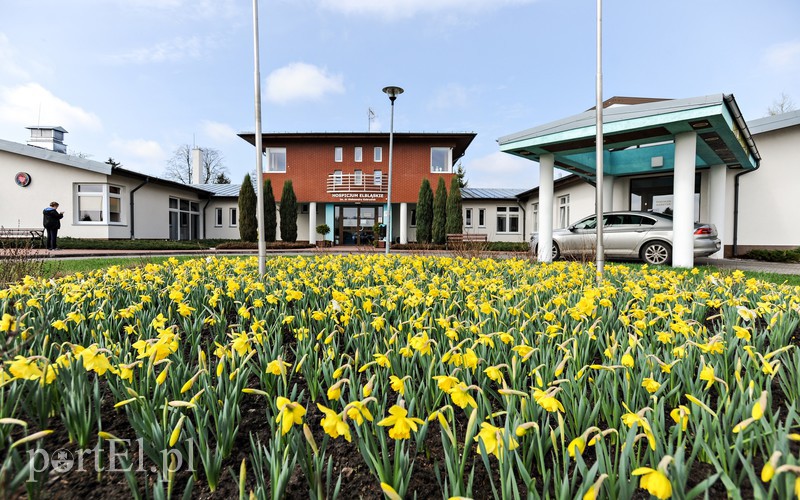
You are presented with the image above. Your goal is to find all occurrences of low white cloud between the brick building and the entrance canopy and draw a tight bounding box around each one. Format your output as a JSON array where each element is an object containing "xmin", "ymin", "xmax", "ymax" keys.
[{"xmin": 464, "ymin": 151, "xmax": 539, "ymax": 189}]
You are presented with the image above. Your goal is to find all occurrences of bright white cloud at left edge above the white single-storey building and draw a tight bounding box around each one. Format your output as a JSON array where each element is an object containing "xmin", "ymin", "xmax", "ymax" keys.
[{"xmin": 0, "ymin": 83, "xmax": 103, "ymax": 132}]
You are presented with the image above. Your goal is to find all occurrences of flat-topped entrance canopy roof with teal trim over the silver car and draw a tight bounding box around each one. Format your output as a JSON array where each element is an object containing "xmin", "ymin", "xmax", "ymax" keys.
[{"xmin": 498, "ymin": 94, "xmax": 760, "ymax": 181}]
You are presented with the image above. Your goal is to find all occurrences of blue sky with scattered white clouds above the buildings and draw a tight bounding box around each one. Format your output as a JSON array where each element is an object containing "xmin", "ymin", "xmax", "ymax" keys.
[{"xmin": 0, "ymin": 0, "xmax": 800, "ymax": 188}]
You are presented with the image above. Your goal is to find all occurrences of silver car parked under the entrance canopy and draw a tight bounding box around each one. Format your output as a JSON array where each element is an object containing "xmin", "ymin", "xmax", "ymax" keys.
[{"xmin": 531, "ymin": 212, "xmax": 721, "ymax": 264}]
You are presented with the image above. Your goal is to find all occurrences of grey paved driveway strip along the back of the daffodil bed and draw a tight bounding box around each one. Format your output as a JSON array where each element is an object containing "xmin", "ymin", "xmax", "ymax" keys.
[{"xmin": 0, "ymin": 246, "xmax": 800, "ymax": 275}]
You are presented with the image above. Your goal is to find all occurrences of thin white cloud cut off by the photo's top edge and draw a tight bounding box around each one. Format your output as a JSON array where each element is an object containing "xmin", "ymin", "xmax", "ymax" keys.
[{"xmin": 320, "ymin": 0, "xmax": 536, "ymax": 20}]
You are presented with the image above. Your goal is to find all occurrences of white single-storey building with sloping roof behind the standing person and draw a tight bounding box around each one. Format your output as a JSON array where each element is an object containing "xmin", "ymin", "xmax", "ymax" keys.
[{"xmin": 0, "ymin": 127, "xmax": 222, "ymax": 240}]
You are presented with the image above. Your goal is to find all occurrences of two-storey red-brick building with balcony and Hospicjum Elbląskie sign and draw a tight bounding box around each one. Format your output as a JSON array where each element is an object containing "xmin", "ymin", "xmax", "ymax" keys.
[{"xmin": 240, "ymin": 132, "xmax": 475, "ymax": 245}]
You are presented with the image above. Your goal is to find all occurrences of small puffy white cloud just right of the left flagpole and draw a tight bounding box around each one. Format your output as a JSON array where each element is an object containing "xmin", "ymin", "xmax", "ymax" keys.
[{"xmin": 264, "ymin": 62, "xmax": 344, "ymax": 104}]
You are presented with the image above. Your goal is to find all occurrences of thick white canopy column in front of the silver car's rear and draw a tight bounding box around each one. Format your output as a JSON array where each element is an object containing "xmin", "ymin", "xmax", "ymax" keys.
[{"xmin": 672, "ymin": 132, "xmax": 697, "ymax": 268}]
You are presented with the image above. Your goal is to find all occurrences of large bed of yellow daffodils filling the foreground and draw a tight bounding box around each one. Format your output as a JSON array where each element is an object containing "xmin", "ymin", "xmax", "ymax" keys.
[{"xmin": 0, "ymin": 255, "xmax": 800, "ymax": 499}]
